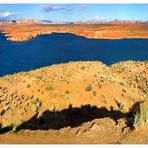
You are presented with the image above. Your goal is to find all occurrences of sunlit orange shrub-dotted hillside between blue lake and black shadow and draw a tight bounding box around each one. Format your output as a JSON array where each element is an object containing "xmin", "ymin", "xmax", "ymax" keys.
[{"xmin": 0, "ymin": 59, "xmax": 148, "ymax": 134}]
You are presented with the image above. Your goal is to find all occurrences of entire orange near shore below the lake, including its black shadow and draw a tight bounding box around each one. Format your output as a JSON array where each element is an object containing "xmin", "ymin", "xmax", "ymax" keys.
[{"xmin": 0, "ymin": 61, "xmax": 148, "ymax": 143}]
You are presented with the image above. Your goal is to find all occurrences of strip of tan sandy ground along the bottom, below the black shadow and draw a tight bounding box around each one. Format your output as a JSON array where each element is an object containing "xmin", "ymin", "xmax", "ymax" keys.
[{"xmin": 0, "ymin": 120, "xmax": 148, "ymax": 144}]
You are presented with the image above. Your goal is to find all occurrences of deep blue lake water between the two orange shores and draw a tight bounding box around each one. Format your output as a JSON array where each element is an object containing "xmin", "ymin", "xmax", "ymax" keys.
[{"xmin": 0, "ymin": 33, "xmax": 148, "ymax": 76}]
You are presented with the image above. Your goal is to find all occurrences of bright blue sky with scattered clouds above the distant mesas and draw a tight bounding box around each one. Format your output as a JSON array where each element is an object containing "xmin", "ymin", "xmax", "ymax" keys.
[{"xmin": 0, "ymin": 4, "xmax": 148, "ymax": 22}]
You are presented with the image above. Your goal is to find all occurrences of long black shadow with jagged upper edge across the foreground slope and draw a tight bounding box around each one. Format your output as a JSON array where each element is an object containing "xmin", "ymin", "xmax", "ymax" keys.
[{"xmin": 14, "ymin": 105, "xmax": 127, "ymax": 131}]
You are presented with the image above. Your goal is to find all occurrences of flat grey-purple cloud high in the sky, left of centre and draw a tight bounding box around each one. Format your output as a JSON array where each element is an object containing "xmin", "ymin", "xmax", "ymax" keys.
[{"xmin": 40, "ymin": 5, "xmax": 72, "ymax": 12}]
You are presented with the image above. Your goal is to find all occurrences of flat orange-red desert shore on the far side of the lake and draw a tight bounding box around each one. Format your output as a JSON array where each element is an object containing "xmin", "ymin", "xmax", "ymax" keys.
[{"xmin": 0, "ymin": 24, "xmax": 148, "ymax": 41}]
